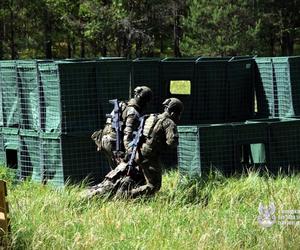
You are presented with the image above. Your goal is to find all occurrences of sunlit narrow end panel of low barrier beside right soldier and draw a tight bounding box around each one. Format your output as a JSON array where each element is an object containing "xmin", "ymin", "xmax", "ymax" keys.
[{"xmin": 178, "ymin": 126, "xmax": 201, "ymax": 176}]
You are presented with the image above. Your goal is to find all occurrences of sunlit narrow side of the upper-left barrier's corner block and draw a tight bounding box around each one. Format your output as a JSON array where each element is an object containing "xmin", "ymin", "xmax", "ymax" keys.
[{"xmin": 38, "ymin": 62, "xmax": 61, "ymax": 133}]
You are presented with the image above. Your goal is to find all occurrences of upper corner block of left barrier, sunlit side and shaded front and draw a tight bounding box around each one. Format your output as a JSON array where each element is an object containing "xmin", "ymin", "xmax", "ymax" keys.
[{"xmin": 39, "ymin": 62, "xmax": 99, "ymax": 134}]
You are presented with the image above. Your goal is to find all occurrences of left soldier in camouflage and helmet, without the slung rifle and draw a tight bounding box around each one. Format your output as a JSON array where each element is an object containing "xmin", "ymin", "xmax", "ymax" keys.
[{"xmin": 92, "ymin": 86, "xmax": 153, "ymax": 169}]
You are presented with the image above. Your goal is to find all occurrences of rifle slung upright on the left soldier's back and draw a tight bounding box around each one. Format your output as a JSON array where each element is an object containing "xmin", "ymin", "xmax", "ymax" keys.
[{"xmin": 106, "ymin": 99, "xmax": 122, "ymax": 157}]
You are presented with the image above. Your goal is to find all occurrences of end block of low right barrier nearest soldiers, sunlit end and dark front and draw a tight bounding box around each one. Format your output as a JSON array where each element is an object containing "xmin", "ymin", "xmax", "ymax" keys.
[{"xmin": 178, "ymin": 124, "xmax": 234, "ymax": 175}]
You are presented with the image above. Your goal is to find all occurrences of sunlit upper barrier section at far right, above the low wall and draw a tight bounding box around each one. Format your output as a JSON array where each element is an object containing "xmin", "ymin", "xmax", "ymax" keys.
[{"xmin": 255, "ymin": 56, "xmax": 300, "ymax": 117}]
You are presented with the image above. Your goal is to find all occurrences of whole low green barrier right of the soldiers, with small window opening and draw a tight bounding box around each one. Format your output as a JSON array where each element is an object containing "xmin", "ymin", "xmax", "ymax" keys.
[{"xmin": 178, "ymin": 118, "xmax": 300, "ymax": 175}]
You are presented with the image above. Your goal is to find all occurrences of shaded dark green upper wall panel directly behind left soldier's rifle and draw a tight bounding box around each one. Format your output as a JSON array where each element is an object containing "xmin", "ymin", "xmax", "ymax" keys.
[{"xmin": 94, "ymin": 60, "xmax": 131, "ymax": 126}]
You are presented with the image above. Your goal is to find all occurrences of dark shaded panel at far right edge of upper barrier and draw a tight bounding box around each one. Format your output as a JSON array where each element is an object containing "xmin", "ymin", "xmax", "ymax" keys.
[{"xmin": 289, "ymin": 56, "xmax": 300, "ymax": 116}]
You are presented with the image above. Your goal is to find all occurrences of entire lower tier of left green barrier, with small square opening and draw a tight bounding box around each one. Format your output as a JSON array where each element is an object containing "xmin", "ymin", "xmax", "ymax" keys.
[{"xmin": 0, "ymin": 129, "xmax": 109, "ymax": 186}]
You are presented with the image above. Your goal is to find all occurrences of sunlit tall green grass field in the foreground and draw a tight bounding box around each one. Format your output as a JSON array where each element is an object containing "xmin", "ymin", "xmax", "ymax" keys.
[{"xmin": 0, "ymin": 168, "xmax": 300, "ymax": 249}]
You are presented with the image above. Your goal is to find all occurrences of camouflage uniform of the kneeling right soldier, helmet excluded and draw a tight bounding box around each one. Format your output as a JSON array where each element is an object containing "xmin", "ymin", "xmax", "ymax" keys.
[{"xmin": 130, "ymin": 112, "xmax": 178, "ymax": 198}]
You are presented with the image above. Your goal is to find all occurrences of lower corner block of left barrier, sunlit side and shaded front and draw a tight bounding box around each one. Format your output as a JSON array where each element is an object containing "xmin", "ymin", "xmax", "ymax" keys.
[{"xmin": 40, "ymin": 134, "xmax": 109, "ymax": 186}]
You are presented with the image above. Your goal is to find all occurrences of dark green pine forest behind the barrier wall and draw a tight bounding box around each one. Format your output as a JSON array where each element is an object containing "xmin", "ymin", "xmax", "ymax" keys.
[{"xmin": 0, "ymin": 0, "xmax": 300, "ymax": 59}]
